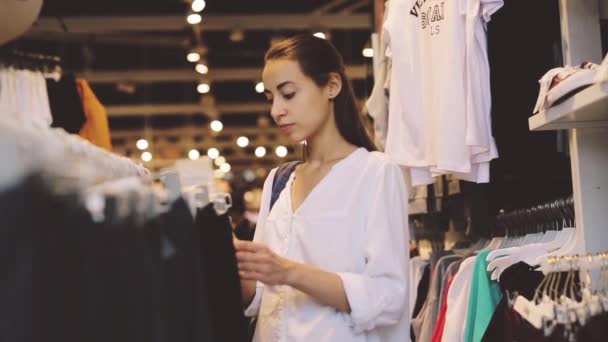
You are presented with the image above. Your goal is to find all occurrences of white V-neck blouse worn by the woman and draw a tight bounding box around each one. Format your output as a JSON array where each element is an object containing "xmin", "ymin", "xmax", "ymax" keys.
[{"xmin": 245, "ymin": 148, "xmax": 410, "ymax": 342}]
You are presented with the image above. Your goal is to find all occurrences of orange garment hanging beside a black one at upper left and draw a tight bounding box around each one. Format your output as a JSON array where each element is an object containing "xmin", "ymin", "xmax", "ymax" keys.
[{"xmin": 76, "ymin": 80, "xmax": 112, "ymax": 151}]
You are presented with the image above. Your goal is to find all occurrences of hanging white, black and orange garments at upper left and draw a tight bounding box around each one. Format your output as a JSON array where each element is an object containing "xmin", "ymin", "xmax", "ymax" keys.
[{"xmin": 0, "ymin": 50, "xmax": 112, "ymax": 151}]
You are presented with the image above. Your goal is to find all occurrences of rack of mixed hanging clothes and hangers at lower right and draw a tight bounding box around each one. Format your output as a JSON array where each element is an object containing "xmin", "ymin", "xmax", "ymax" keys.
[{"xmin": 411, "ymin": 198, "xmax": 608, "ymax": 342}]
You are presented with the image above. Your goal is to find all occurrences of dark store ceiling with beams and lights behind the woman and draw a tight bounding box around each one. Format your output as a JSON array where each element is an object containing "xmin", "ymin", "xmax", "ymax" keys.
[{"xmin": 19, "ymin": 0, "xmax": 372, "ymax": 176}]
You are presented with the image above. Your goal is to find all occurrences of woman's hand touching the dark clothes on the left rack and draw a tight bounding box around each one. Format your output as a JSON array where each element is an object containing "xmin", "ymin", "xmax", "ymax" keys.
[{"xmin": 234, "ymin": 239, "xmax": 297, "ymax": 285}]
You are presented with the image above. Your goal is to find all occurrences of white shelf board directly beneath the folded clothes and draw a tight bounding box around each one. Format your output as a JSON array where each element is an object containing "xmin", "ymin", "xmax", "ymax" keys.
[{"xmin": 528, "ymin": 82, "xmax": 608, "ymax": 131}]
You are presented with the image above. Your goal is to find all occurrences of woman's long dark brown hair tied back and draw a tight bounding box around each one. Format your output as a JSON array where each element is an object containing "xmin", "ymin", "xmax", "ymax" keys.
[{"xmin": 264, "ymin": 34, "xmax": 377, "ymax": 151}]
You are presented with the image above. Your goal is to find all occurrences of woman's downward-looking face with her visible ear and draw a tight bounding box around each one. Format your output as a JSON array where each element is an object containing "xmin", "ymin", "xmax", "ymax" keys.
[{"xmin": 262, "ymin": 59, "xmax": 335, "ymax": 144}]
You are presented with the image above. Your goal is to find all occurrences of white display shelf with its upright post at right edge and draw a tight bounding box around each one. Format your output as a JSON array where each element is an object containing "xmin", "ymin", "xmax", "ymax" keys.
[{"xmin": 528, "ymin": 0, "xmax": 608, "ymax": 254}]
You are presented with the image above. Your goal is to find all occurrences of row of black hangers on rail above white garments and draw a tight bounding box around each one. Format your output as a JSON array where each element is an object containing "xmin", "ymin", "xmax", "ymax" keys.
[{"xmin": 496, "ymin": 196, "xmax": 575, "ymax": 236}]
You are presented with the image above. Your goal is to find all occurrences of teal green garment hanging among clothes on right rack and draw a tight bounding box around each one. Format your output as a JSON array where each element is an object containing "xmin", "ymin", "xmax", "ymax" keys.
[{"xmin": 464, "ymin": 251, "xmax": 502, "ymax": 342}]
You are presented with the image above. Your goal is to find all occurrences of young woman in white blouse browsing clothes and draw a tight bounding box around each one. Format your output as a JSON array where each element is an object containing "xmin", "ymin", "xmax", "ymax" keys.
[{"xmin": 235, "ymin": 35, "xmax": 409, "ymax": 342}]
